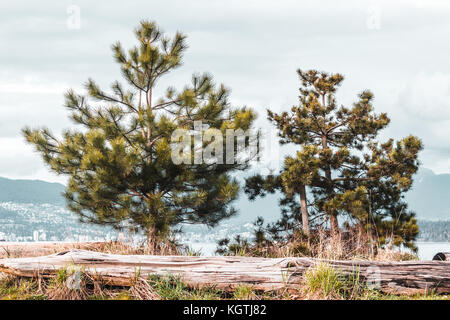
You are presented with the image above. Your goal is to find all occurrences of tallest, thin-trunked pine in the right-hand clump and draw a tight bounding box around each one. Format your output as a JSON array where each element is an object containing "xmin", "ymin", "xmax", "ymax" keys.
[{"xmin": 268, "ymin": 70, "xmax": 389, "ymax": 235}]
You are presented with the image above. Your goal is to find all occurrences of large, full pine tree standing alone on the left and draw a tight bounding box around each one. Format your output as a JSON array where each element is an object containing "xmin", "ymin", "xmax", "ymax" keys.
[{"xmin": 23, "ymin": 21, "xmax": 255, "ymax": 248}]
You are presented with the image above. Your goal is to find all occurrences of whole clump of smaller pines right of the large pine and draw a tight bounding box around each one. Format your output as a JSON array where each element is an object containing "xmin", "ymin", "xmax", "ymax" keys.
[{"xmin": 245, "ymin": 70, "xmax": 422, "ymax": 248}]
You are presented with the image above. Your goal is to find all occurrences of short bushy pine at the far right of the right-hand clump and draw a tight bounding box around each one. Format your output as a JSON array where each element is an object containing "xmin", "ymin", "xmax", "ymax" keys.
[{"xmin": 334, "ymin": 136, "xmax": 422, "ymax": 249}]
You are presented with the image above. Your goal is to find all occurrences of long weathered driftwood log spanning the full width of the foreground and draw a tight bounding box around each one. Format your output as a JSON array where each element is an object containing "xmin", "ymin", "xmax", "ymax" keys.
[{"xmin": 0, "ymin": 250, "xmax": 450, "ymax": 294}]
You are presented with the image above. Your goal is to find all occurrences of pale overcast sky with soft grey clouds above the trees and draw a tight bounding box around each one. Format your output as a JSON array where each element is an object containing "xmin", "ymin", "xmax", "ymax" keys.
[{"xmin": 0, "ymin": 0, "xmax": 450, "ymax": 181}]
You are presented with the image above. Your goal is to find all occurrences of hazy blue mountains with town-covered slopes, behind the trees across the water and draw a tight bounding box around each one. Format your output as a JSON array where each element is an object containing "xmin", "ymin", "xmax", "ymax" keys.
[{"xmin": 0, "ymin": 168, "xmax": 450, "ymax": 242}]
